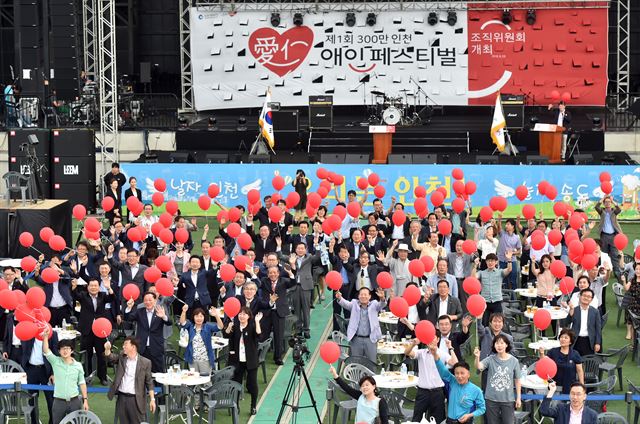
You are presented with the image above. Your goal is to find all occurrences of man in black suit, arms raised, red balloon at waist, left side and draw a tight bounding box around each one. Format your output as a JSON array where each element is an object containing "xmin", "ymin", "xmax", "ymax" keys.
[{"xmin": 71, "ymin": 278, "xmax": 113, "ymax": 386}]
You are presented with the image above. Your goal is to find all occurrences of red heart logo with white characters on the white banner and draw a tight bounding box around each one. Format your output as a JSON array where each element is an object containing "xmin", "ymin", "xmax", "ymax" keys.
[{"xmin": 249, "ymin": 26, "xmax": 313, "ymax": 77}]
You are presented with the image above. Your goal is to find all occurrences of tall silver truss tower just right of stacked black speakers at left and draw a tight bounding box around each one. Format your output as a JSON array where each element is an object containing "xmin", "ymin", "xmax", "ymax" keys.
[{"xmin": 94, "ymin": 0, "xmax": 119, "ymax": 191}]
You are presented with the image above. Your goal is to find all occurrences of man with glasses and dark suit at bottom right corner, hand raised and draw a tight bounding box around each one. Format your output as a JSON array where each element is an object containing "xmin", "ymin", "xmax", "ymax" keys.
[{"xmin": 540, "ymin": 382, "xmax": 598, "ymax": 424}]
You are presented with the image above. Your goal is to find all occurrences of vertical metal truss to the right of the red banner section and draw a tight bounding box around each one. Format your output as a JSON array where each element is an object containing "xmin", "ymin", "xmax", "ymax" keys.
[{"xmin": 616, "ymin": 0, "xmax": 631, "ymax": 110}]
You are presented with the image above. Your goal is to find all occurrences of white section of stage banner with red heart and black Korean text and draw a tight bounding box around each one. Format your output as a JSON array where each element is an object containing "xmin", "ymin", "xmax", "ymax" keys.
[{"xmin": 191, "ymin": 8, "xmax": 468, "ymax": 110}]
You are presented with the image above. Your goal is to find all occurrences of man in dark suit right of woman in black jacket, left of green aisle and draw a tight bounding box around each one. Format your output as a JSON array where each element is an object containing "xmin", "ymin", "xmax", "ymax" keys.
[{"xmin": 262, "ymin": 266, "xmax": 296, "ymax": 365}]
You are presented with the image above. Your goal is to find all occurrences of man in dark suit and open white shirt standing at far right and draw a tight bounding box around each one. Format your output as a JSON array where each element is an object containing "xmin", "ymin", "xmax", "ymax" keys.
[{"xmin": 569, "ymin": 288, "xmax": 602, "ymax": 356}]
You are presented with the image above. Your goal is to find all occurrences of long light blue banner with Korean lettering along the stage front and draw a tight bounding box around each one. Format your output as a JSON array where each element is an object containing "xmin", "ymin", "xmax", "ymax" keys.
[{"xmin": 122, "ymin": 163, "xmax": 640, "ymax": 219}]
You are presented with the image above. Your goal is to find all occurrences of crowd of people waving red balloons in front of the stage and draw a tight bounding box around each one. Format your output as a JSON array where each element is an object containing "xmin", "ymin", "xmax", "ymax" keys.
[{"xmin": 1, "ymin": 164, "xmax": 640, "ymax": 424}]
